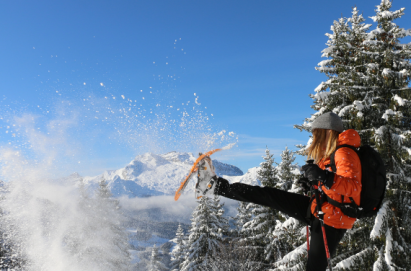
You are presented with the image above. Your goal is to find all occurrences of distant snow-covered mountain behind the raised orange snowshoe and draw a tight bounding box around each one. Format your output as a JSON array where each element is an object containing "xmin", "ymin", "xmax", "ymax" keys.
[{"xmin": 82, "ymin": 152, "xmax": 246, "ymax": 197}]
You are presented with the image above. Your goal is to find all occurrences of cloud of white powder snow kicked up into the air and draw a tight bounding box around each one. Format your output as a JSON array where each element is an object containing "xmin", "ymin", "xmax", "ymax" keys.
[{"xmin": 0, "ymin": 92, "xmax": 236, "ymax": 271}]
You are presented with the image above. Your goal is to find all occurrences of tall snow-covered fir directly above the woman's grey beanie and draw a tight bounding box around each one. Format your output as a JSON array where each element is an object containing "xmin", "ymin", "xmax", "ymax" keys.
[{"xmin": 295, "ymin": 8, "xmax": 372, "ymax": 134}]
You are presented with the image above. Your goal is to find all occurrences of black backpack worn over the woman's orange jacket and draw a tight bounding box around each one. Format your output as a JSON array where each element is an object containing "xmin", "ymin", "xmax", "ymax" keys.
[{"xmin": 326, "ymin": 145, "xmax": 387, "ymax": 218}]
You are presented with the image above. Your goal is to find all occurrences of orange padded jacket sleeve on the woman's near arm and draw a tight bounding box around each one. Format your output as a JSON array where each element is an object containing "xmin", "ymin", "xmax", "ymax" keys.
[{"xmin": 326, "ymin": 148, "xmax": 362, "ymax": 197}]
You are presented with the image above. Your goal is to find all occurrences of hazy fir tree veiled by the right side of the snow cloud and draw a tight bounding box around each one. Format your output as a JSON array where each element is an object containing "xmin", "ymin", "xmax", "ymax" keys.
[{"xmin": 65, "ymin": 179, "xmax": 130, "ymax": 270}]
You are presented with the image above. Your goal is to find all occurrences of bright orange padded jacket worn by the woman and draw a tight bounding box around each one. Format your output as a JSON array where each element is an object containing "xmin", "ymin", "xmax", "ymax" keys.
[{"xmin": 311, "ymin": 129, "xmax": 362, "ymax": 229}]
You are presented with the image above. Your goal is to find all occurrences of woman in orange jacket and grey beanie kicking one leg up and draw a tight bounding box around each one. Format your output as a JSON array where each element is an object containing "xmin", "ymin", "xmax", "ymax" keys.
[{"xmin": 196, "ymin": 112, "xmax": 361, "ymax": 271}]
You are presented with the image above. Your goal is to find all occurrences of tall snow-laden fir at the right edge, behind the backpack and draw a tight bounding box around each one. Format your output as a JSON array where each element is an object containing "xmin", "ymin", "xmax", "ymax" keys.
[{"xmin": 342, "ymin": 0, "xmax": 411, "ymax": 270}]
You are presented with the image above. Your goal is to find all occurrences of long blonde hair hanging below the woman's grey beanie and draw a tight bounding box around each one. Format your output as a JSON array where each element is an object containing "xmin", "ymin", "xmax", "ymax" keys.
[{"xmin": 304, "ymin": 129, "xmax": 340, "ymax": 164}]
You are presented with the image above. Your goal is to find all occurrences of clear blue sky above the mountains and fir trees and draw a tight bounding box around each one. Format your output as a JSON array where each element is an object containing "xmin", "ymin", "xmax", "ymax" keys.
[{"xmin": 0, "ymin": 0, "xmax": 411, "ymax": 175}]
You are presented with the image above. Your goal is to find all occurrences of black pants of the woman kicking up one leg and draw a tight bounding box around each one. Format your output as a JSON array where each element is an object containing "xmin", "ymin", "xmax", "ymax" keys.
[{"xmin": 215, "ymin": 178, "xmax": 346, "ymax": 271}]
